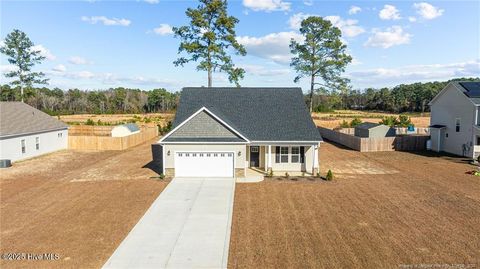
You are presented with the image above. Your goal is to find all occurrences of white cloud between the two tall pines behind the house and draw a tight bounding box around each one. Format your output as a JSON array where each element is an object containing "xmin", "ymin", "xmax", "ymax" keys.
[{"xmin": 237, "ymin": 31, "xmax": 303, "ymax": 64}]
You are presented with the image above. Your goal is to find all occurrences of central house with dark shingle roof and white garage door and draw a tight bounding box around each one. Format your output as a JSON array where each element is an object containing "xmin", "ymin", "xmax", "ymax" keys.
[{"xmin": 158, "ymin": 88, "xmax": 322, "ymax": 177}]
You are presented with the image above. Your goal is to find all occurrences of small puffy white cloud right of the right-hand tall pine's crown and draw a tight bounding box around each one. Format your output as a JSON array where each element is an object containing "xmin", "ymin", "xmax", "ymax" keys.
[{"xmin": 364, "ymin": 26, "xmax": 412, "ymax": 49}]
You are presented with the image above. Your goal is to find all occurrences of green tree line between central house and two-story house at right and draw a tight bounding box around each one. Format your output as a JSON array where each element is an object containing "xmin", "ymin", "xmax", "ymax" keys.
[{"xmin": 312, "ymin": 77, "xmax": 480, "ymax": 113}]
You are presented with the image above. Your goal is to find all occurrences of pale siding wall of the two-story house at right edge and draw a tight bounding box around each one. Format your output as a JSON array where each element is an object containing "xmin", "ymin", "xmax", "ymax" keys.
[{"xmin": 430, "ymin": 84, "xmax": 476, "ymax": 156}]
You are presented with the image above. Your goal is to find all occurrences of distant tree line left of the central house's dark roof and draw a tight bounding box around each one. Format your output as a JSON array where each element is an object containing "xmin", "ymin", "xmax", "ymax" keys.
[{"xmin": 0, "ymin": 85, "xmax": 179, "ymax": 115}]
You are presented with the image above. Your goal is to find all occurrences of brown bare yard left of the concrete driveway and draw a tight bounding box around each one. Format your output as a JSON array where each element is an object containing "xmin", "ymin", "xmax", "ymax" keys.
[{"xmin": 0, "ymin": 141, "xmax": 167, "ymax": 268}]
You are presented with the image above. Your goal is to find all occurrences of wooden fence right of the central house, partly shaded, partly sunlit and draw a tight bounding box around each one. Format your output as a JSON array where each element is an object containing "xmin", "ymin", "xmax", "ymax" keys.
[{"xmin": 318, "ymin": 127, "xmax": 430, "ymax": 152}]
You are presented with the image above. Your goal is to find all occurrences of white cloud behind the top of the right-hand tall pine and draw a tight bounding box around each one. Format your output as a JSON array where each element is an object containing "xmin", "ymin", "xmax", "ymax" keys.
[{"xmin": 288, "ymin": 13, "xmax": 365, "ymax": 37}]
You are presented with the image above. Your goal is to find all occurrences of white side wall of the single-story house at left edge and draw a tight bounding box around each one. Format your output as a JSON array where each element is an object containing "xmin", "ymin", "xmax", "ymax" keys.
[{"xmin": 0, "ymin": 130, "xmax": 68, "ymax": 162}]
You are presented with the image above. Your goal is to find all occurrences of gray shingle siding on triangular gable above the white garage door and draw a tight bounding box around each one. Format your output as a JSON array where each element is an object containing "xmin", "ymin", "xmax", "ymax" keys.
[{"xmin": 170, "ymin": 111, "xmax": 237, "ymax": 138}]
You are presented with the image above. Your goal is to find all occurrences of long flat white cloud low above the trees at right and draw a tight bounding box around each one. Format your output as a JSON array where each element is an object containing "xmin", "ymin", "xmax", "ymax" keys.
[{"xmin": 348, "ymin": 59, "xmax": 480, "ymax": 87}]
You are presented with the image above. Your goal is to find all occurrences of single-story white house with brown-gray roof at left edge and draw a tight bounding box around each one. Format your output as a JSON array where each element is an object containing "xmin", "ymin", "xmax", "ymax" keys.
[{"xmin": 0, "ymin": 102, "xmax": 68, "ymax": 162}]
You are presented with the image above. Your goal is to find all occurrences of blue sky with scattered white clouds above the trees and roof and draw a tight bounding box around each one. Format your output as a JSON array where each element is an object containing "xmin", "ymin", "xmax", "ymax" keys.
[{"xmin": 0, "ymin": 0, "xmax": 480, "ymax": 91}]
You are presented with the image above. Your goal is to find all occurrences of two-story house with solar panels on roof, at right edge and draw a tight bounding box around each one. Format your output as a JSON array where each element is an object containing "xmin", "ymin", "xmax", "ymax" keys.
[{"xmin": 429, "ymin": 82, "xmax": 480, "ymax": 158}]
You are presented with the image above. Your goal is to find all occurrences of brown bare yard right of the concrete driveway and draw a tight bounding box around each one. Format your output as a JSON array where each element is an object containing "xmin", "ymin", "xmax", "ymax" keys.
[{"xmin": 229, "ymin": 143, "xmax": 480, "ymax": 268}]
